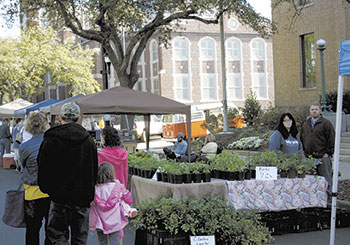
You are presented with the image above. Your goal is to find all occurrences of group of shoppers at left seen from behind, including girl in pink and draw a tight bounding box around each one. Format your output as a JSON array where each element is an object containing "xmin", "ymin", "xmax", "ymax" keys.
[{"xmin": 0, "ymin": 103, "xmax": 131, "ymax": 245}]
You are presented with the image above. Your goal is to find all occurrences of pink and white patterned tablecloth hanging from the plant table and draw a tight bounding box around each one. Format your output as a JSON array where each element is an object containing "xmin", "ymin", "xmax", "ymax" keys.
[{"xmin": 221, "ymin": 175, "xmax": 328, "ymax": 211}]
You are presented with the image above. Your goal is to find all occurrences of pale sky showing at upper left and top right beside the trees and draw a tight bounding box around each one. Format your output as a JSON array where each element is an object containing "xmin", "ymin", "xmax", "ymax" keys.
[{"xmin": 0, "ymin": 0, "xmax": 271, "ymax": 37}]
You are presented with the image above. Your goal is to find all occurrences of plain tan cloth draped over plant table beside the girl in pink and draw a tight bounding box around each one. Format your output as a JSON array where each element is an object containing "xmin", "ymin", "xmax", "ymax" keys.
[{"xmin": 131, "ymin": 175, "xmax": 228, "ymax": 205}]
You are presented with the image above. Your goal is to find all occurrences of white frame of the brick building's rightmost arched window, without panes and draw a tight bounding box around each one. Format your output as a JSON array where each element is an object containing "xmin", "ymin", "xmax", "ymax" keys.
[{"xmin": 249, "ymin": 37, "xmax": 269, "ymax": 100}]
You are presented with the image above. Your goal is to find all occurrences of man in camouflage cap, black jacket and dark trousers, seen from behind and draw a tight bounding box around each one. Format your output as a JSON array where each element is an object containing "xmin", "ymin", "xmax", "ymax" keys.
[{"xmin": 38, "ymin": 103, "xmax": 97, "ymax": 244}]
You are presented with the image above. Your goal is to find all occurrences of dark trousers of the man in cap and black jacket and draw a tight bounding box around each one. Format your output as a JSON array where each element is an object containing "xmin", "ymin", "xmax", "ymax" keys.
[{"xmin": 48, "ymin": 201, "xmax": 89, "ymax": 245}]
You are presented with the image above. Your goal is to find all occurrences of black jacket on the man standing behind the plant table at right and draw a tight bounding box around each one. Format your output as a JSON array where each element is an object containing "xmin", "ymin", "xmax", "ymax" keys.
[{"xmin": 300, "ymin": 117, "xmax": 335, "ymax": 158}]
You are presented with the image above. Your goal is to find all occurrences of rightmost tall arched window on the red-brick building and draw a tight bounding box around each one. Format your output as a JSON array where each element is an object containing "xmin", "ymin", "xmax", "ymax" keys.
[{"xmin": 250, "ymin": 38, "xmax": 267, "ymax": 99}]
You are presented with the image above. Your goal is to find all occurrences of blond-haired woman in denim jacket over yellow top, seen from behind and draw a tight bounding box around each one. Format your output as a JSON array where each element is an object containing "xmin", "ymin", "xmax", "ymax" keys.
[{"xmin": 18, "ymin": 112, "xmax": 51, "ymax": 245}]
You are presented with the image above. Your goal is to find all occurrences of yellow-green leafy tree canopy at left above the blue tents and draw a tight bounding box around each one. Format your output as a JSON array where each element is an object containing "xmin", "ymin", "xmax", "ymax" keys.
[{"xmin": 0, "ymin": 27, "xmax": 99, "ymax": 103}]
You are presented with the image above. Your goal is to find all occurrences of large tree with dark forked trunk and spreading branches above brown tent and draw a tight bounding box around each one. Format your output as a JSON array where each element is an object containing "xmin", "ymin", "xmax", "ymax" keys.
[{"xmin": 2, "ymin": 0, "xmax": 272, "ymax": 88}]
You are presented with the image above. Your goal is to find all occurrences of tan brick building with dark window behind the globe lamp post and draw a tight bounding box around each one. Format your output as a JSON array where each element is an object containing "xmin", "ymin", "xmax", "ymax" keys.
[{"xmin": 272, "ymin": 0, "xmax": 350, "ymax": 107}]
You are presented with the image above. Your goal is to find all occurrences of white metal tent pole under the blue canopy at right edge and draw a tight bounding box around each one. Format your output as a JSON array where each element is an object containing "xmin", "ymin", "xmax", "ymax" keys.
[{"xmin": 329, "ymin": 76, "xmax": 344, "ymax": 245}]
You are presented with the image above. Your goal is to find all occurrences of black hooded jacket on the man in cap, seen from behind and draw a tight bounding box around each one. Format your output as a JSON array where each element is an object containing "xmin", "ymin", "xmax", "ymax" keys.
[{"xmin": 38, "ymin": 123, "xmax": 98, "ymax": 207}]
